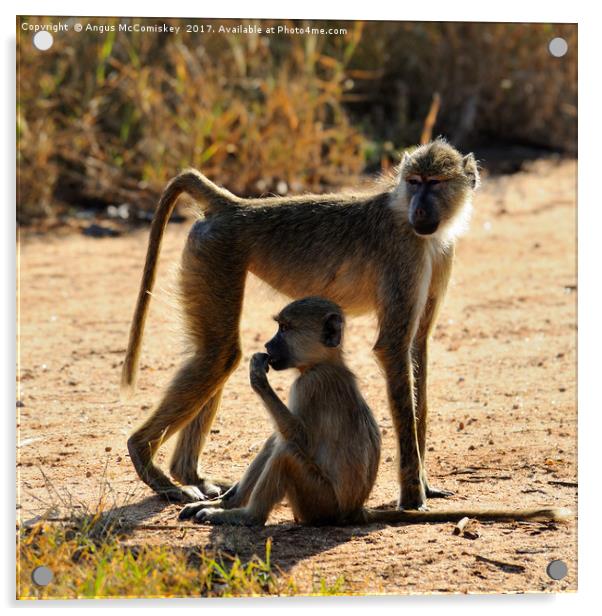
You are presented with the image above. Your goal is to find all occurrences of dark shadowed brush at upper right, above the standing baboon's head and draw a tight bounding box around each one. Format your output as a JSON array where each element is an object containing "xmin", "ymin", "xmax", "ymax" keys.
[{"xmin": 350, "ymin": 22, "xmax": 577, "ymax": 154}]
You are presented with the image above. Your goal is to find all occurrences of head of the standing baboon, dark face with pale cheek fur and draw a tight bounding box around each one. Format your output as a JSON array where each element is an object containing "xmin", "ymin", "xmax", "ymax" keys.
[{"xmin": 400, "ymin": 139, "xmax": 479, "ymax": 236}]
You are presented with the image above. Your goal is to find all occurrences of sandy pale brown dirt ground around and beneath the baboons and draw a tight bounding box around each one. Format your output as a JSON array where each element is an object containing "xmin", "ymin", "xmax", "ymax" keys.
[{"xmin": 17, "ymin": 160, "xmax": 577, "ymax": 594}]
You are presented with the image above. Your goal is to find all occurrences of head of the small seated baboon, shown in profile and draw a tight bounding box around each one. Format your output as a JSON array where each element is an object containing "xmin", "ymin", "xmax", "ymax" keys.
[{"xmin": 265, "ymin": 297, "xmax": 343, "ymax": 370}]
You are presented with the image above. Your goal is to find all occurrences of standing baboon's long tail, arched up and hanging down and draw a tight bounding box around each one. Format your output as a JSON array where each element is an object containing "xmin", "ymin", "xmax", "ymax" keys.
[{"xmin": 121, "ymin": 169, "xmax": 242, "ymax": 397}]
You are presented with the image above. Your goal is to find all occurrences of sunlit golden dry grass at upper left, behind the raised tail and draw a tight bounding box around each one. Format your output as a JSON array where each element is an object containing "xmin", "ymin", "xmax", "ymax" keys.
[{"xmin": 18, "ymin": 20, "xmax": 364, "ymax": 222}]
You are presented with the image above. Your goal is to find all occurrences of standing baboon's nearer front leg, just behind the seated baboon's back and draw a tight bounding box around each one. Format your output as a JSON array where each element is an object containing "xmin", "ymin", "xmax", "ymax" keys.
[{"xmin": 374, "ymin": 307, "xmax": 426, "ymax": 509}]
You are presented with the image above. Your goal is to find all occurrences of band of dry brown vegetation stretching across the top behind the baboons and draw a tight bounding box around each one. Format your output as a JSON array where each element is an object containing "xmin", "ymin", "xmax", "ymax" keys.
[{"xmin": 17, "ymin": 18, "xmax": 577, "ymax": 223}]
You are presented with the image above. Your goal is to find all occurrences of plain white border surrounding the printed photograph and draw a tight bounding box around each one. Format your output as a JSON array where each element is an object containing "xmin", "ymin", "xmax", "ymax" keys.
[{"xmin": 0, "ymin": 0, "xmax": 602, "ymax": 616}]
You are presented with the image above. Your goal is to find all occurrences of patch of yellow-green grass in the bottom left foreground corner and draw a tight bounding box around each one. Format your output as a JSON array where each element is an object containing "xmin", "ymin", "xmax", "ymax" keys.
[{"xmin": 17, "ymin": 515, "xmax": 345, "ymax": 599}]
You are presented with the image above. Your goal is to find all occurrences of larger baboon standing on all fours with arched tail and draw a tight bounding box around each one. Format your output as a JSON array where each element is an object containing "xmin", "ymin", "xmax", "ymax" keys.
[{"xmin": 122, "ymin": 139, "xmax": 479, "ymax": 509}]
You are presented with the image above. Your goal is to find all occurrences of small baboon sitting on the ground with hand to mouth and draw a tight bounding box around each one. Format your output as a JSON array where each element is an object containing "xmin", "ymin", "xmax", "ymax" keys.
[{"xmin": 180, "ymin": 297, "xmax": 566, "ymax": 525}]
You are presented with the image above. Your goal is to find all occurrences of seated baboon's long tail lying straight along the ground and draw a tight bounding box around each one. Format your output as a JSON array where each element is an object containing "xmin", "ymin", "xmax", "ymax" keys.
[{"xmin": 364, "ymin": 507, "xmax": 571, "ymax": 524}]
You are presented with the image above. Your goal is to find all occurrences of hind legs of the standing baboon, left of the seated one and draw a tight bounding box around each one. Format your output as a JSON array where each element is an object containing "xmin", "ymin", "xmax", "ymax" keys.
[{"xmin": 128, "ymin": 236, "xmax": 246, "ymax": 501}]
